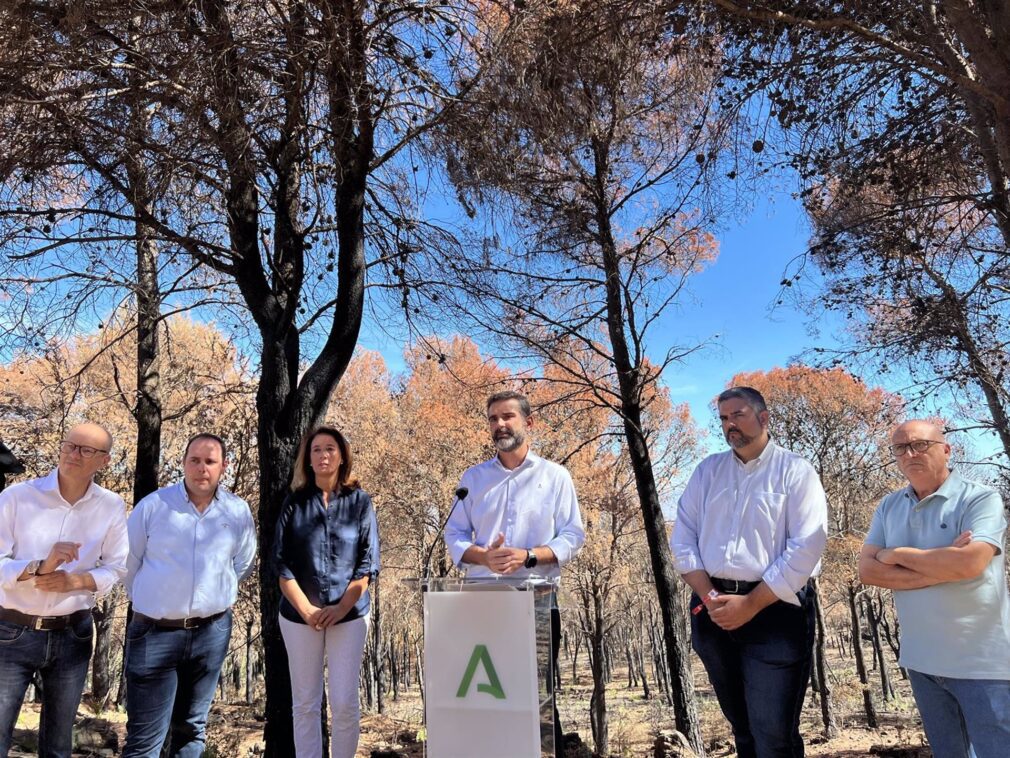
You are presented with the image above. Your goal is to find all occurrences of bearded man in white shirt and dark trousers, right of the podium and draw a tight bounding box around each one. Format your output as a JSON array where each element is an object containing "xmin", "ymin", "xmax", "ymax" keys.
[{"xmin": 671, "ymin": 387, "xmax": 827, "ymax": 758}]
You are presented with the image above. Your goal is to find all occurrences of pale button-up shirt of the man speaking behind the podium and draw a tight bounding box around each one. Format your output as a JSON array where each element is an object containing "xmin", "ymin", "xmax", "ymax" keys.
[{"xmin": 445, "ymin": 452, "xmax": 586, "ymax": 578}]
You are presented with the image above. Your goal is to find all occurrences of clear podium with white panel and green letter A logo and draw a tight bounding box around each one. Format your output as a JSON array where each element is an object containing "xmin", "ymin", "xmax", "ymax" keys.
[{"xmin": 404, "ymin": 576, "xmax": 558, "ymax": 758}]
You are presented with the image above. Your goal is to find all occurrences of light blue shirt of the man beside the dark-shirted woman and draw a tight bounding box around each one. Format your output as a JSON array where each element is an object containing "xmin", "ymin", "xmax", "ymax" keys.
[{"xmin": 124, "ymin": 482, "xmax": 256, "ymax": 619}]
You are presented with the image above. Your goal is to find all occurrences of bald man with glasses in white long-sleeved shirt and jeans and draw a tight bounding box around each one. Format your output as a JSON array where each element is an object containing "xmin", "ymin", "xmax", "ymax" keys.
[{"xmin": 0, "ymin": 423, "xmax": 129, "ymax": 758}]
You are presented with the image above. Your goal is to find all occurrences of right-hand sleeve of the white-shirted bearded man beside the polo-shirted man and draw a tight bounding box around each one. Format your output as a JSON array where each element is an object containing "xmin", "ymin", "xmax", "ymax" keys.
[{"xmin": 762, "ymin": 461, "xmax": 827, "ymax": 605}]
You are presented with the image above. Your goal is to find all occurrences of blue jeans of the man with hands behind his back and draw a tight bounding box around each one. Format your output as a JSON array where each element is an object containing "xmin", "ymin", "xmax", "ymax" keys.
[{"xmin": 122, "ymin": 609, "xmax": 231, "ymax": 758}]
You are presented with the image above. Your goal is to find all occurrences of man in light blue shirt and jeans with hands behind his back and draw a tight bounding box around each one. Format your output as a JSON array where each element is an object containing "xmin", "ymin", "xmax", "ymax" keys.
[{"xmin": 123, "ymin": 434, "xmax": 256, "ymax": 758}]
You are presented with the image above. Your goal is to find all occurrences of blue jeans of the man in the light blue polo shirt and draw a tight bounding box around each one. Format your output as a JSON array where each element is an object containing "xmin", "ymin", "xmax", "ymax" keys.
[{"xmin": 908, "ymin": 669, "xmax": 1010, "ymax": 758}]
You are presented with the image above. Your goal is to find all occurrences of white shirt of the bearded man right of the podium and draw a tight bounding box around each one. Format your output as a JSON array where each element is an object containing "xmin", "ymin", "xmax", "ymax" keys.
[{"xmin": 670, "ymin": 442, "xmax": 827, "ymax": 605}]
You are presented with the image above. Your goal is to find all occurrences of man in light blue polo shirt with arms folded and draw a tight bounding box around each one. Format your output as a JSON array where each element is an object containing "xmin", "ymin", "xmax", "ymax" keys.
[{"xmin": 860, "ymin": 420, "xmax": 1010, "ymax": 758}]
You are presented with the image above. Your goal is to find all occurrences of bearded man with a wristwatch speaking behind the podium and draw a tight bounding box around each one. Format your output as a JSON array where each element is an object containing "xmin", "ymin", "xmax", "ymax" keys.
[{"xmin": 445, "ymin": 392, "xmax": 586, "ymax": 755}]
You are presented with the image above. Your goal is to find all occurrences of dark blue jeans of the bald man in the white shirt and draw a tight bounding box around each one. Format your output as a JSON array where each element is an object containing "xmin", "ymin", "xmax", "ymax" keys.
[{"xmin": 0, "ymin": 613, "xmax": 95, "ymax": 758}]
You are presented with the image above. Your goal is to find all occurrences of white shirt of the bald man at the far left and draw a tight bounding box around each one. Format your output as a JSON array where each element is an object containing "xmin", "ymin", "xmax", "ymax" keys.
[{"xmin": 0, "ymin": 469, "xmax": 128, "ymax": 615}]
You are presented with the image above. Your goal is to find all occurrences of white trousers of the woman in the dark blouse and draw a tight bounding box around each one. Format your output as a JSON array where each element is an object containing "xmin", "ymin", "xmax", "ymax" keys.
[{"xmin": 281, "ymin": 617, "xmax": 369, "ymax": 758}]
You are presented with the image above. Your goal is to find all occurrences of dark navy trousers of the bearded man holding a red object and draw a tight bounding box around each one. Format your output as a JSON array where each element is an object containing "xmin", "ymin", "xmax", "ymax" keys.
[{"xmin": 691, "ymin": 583, "xmax": 815, "ymax": 758}]
